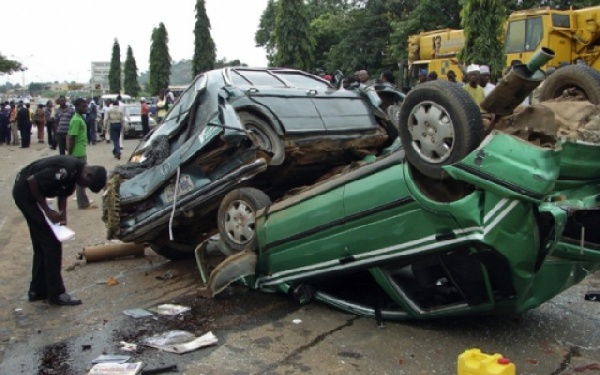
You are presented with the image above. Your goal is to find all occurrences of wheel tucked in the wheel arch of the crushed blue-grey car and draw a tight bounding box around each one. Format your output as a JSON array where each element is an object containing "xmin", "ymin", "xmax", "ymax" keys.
[{"xmin": 238, "ymin": 112, "xmax": 285, "ymax": 165}]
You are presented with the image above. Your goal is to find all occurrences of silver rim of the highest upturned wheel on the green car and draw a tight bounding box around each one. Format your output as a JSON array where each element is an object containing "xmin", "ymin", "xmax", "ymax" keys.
[{"xmin": 408, "ymin": 101, "xmax": 454, "ymax": 164}]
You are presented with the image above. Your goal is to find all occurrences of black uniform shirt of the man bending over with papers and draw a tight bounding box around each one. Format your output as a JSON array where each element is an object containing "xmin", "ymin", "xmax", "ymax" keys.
[{"xmin": 19, "ymin": 155, "xmax": 85, "ymax": 198}]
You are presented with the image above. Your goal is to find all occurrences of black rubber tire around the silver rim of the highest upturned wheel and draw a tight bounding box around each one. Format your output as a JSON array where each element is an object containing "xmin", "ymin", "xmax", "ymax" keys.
[{"xmin": 399, "ymin": 81, "xmax": 484, "ymax": 180}]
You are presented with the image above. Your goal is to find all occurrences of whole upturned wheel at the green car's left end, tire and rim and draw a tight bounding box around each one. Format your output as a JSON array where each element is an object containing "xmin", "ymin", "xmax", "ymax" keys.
[{"xmin": 217, "ymin": 188, "xmax": 271, "ymax": 252}]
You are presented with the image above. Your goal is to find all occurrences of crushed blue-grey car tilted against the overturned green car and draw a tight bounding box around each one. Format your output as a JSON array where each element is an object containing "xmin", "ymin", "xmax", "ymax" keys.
[{"xmin": 103, "ymin": 67, "xmax": 398, "ymax": 259}]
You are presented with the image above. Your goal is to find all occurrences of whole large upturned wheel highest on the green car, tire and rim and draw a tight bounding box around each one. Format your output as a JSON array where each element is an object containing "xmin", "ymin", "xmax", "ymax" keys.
[{"xmin": 399, "ymin": 81, "xmax": 484, "ymax": 179}]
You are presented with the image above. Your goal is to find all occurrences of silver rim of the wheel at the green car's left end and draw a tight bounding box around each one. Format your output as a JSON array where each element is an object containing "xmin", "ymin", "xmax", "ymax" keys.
[{"xmin": 223, "ymin": 200, "xmax": 256, "ymax": 245}]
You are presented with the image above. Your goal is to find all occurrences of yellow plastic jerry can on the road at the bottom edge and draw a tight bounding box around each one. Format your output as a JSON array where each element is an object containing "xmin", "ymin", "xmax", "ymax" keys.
[{"xmin": 458, "ymin": 349, "xmax": 517, "ymax": 375}]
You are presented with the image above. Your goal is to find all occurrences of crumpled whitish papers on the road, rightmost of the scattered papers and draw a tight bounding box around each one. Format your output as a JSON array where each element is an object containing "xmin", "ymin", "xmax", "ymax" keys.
[{"xmin": 142, "ymin": 330, "xmax": 219, "ymax": 354}]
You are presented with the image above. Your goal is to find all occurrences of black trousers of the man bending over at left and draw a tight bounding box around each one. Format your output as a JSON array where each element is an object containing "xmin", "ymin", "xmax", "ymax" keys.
[{"xmin": 13, "ymin": 179, "xmax": 65, "ymax": 299}]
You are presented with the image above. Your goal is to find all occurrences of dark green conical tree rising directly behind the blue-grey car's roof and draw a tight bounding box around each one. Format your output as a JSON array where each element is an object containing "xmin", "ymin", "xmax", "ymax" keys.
[{"xmin": 273, "ymin": 0, "xmax": 314, "ymax": 70}]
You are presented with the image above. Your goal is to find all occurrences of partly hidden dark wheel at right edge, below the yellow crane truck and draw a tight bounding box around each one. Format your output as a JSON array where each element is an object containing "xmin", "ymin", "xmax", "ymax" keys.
[{"xmin": 540, "ymin": 65, "xmax": 600, "ymax": 104}]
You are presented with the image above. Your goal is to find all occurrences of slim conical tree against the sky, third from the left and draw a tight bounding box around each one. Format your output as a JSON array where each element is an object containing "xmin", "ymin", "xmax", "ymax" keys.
[{"xmin": 148, "ymin": 22, "xmax": 171, "ymax": 95}]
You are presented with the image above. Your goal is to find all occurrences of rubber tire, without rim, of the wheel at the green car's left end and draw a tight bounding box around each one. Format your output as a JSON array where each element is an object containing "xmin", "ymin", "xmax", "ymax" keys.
[{"xmin": 217, "ymin": 187, "xmax": 271, "ymax": 252}]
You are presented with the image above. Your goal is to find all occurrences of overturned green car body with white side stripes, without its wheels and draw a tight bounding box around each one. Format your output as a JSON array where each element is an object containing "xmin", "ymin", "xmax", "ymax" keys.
[{"xmin": 244, "ymin": 133, "xmax": 600, "ymax": 319}]
